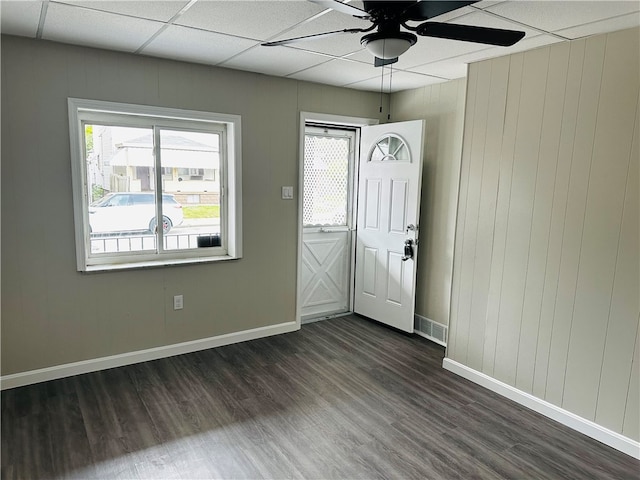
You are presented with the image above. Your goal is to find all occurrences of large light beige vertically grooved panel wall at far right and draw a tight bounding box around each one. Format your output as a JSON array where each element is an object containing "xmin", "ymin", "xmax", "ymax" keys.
[{"xmin": 447, "ymin": 29, "xmax": 640, "ymax": 440}]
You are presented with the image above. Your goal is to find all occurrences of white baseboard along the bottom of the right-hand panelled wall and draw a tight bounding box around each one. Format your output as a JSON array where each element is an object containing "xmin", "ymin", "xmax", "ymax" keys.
[{"xmin": 442, "ymin": 358, "xmax": 640, "ymax": 460}]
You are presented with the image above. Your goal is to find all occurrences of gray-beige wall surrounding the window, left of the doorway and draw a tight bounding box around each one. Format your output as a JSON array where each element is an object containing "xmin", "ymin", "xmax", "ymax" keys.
[{"xmin": 1, "ymin": 36, "xmax": 388, "ymax": 375}]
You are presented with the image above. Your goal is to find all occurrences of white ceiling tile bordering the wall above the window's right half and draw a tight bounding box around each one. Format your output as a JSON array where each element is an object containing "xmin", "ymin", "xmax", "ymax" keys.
[{"xmin": 141, "ymin": 25, "xmax": 257, "ymax": 65}]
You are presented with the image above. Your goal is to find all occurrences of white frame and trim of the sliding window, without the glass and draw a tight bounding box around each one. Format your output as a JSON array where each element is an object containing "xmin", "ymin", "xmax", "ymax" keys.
[{"xmin": 68, "ymin": 98, "xmax": 242, "ymax": 272}]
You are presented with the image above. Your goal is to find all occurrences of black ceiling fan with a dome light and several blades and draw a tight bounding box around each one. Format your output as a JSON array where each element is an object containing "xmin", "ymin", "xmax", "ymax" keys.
[{"xmin": 262, "ymin": 0, "xmax": 525, "ymax": 67}]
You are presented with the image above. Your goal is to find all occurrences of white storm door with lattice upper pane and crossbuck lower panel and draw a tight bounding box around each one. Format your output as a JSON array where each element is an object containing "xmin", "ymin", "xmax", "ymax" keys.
[{"xmin": 299, "ymin": 126, "xmax": 356, "ymax": 321}]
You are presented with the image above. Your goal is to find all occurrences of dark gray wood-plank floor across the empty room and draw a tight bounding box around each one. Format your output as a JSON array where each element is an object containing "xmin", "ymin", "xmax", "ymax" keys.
[{"xmin": 1, "ymin": 316, "xmax": 640, "ymax": 480}]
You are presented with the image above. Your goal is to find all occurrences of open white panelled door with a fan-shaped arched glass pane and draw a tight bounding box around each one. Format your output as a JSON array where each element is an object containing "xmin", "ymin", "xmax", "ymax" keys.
[{"xmin": 354, "ymin": 120, "xmax": 423, "ymax": 332}]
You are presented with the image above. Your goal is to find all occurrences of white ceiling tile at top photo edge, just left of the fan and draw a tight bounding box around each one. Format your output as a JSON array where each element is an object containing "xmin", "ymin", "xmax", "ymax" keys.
[{"xmin": 176, "ymin": 0, "xmax": 323, "ymax": 40}]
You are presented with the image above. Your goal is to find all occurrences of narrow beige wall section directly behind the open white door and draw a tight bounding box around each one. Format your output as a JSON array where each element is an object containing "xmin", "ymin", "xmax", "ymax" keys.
[{"xmin": 391, "ymin": 78, "xmax": 466, "ymax": 325}]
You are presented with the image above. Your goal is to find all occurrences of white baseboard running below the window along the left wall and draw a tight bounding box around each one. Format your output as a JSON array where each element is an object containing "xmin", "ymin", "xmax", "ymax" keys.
[{"xmin": 0, "ymin": 322, "xmax": 300, "ymax": 390}]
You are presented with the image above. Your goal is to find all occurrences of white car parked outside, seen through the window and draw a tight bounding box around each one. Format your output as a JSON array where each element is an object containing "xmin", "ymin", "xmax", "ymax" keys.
[{"xmin": 89, "ymin": 192, "xmax": 184, "ymax": 233}]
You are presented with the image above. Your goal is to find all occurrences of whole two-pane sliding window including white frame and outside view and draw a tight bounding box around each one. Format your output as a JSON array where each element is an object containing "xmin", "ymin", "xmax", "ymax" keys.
[{"xmin": 69, "ymin": 99, "xmax": 242, "ymax": 271}]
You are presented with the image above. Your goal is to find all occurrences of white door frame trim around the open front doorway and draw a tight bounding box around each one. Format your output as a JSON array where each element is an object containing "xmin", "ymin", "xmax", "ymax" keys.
[{"xmin": 296, "ymin": 112, "xmax": 380, "ymax": 328}]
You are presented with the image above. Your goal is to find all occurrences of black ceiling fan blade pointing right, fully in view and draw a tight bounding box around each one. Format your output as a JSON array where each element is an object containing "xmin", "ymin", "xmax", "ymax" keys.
[{"xmin": 416, "ymin": 22, "xmax": 525, "ymax": 47}]
